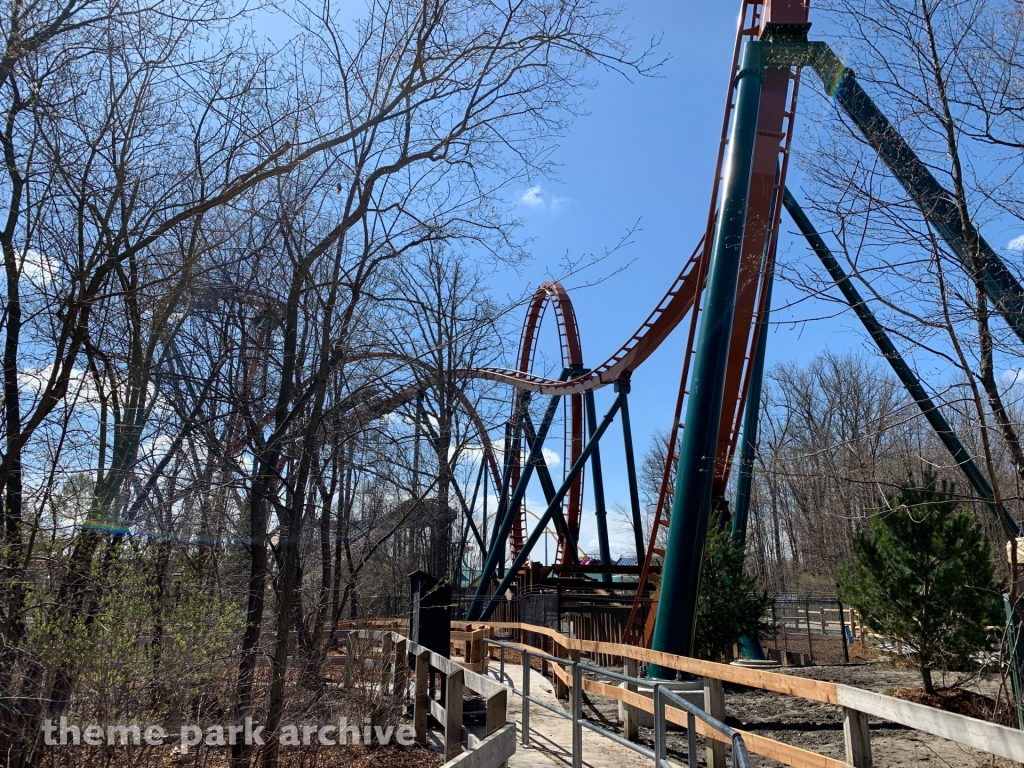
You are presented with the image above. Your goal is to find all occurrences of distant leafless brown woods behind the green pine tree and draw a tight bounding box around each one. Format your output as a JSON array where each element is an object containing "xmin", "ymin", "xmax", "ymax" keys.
[{"xmin": 748, "ymin": 351, "xmax": 1020, "ymax": 595}]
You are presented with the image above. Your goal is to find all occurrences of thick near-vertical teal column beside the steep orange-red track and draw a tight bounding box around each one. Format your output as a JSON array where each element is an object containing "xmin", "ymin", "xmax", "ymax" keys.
[{"xmin": 648, "ymin": 42, "xmax": 764, "ymax": 678}]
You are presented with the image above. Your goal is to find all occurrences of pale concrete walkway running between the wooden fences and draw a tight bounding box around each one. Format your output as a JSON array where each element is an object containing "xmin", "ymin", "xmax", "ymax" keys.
[{"xmin": 488, "ymin": 662, "xmax": 653, "ymax": 768}]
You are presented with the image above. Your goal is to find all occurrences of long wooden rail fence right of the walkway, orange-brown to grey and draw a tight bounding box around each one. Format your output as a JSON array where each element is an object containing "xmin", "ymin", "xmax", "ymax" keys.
[{"xmin": 488, "ymin": 622, "xmax": 1024, "ymax": 768}]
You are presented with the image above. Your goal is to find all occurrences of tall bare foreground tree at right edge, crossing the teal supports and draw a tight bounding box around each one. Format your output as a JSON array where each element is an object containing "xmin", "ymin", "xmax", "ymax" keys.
[{"xmin": 784, "ymin": 0, "xmax": 1024, "ymax": 599}]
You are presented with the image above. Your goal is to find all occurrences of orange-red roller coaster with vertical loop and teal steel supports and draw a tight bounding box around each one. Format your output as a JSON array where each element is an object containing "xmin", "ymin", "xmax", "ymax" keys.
[{"xmin": 391, "ymin": 0, "xmax": 1024, "ymax": 676}]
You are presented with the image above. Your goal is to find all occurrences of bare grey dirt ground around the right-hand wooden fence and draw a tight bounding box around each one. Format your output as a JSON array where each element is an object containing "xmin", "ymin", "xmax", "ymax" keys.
[{"xmin": 584, "ymin": 664, "xmax": 1016, "ymax": 768}]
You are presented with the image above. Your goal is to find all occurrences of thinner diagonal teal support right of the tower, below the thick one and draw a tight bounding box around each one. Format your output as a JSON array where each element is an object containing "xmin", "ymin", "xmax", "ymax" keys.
[{"xmin": 782, "ymin": 189, "xmax": 1020, "ymax": 537}]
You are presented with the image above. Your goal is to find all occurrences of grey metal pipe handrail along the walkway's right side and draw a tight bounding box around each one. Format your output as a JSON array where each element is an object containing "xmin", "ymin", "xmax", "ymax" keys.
[{"xmin": 483, "ymin": 638, "xmax": 751, "ymax": 768}]
